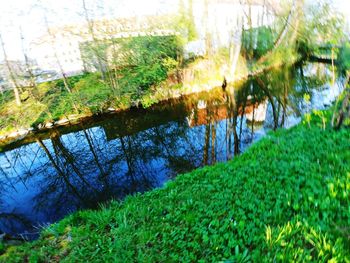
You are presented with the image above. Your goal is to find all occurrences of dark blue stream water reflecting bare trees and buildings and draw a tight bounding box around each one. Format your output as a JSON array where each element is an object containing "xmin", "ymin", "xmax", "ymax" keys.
[{"xmin": 0, "ymin": 64, "xmax": 342, "ymax": 239}]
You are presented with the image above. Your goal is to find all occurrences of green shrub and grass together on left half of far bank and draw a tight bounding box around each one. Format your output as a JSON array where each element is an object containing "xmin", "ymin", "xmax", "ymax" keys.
[{"xmin": 0, "ymin": 36, "xmax": 182, "ymax": 136}]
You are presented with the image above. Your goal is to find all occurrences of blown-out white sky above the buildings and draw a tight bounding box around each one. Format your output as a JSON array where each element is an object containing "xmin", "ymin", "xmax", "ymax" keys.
[{"xmin": 0, "ymin": 0, "xmax": 350, "ymax": 61}]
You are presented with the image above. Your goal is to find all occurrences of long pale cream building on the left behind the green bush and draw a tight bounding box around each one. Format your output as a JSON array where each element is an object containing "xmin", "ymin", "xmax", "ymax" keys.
[{"xmin": 30, "ymin": 16, "xmax": 175, "ymax": 76}]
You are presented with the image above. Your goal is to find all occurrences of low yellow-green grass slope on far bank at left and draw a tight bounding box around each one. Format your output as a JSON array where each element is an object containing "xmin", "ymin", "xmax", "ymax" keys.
[{"xmin": 0, "ymin": 73, "xmax": 165, "ymax": 138}]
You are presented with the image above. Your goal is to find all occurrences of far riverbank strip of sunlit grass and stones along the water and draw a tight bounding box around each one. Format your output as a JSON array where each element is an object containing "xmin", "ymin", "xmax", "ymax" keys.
[{"xmin": 0, "ymin": 49, "xmax": 301, "ymax": 148}]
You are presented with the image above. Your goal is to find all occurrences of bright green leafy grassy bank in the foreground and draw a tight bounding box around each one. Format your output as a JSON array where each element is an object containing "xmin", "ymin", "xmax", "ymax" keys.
[{"xmin": 0, "ymin": 110, "xmax": 350, "ymax": 262}]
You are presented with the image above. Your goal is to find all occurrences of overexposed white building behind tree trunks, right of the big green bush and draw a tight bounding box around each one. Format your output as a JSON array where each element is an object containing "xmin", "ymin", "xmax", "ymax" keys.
[{"xmin": 186, "ymin": 0, "xmax": 281, "ymax": 55}]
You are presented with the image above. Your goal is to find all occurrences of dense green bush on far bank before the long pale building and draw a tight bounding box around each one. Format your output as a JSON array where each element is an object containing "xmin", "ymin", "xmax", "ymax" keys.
[{"xmin": 114, "ymin": 36, "xmax": 182, "ymax": 100}]
